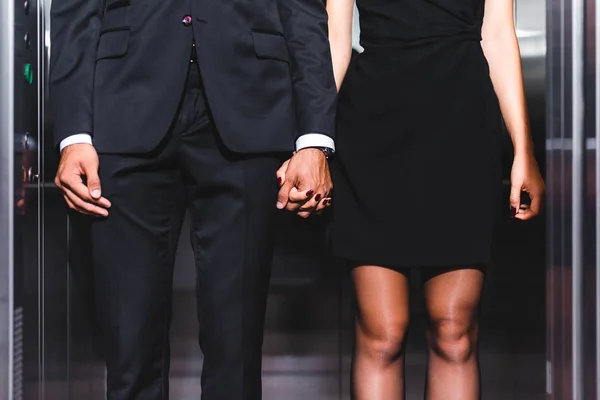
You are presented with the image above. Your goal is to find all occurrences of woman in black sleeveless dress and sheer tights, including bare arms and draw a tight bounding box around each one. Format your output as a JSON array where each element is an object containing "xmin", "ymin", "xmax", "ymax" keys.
[{"xmin": 327, "ymin": 0, "xmax": 544, "ymax": 400}]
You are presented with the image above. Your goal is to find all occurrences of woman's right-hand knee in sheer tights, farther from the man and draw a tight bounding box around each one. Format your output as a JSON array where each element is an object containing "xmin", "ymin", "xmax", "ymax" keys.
[{"xmin": 429, "ymin": 319, "xmax": 477, "ymax": 363}]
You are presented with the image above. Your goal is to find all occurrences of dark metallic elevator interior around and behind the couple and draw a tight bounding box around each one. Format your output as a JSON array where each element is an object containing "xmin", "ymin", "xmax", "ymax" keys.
[{"xmin": 0, "ymin": 0, "xmax": 600, "ymax": 400}]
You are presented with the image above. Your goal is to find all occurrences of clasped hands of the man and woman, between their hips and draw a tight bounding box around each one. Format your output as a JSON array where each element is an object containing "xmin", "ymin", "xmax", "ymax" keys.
[{"xmin": 277, "ymin": 148, "xmax": 333, "ymax": 218}]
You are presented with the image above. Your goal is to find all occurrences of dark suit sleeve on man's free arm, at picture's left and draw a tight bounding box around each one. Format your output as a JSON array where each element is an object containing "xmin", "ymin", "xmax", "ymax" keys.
[{"xmin": 49, "ymin": 0, "xmax": 104, "ymax": 146}]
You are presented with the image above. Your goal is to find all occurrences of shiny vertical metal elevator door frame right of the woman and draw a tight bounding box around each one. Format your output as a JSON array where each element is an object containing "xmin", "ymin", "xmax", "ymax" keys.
[{"xmin": 546, "ymin": 0, "xmax": 600, "ymax": 394}]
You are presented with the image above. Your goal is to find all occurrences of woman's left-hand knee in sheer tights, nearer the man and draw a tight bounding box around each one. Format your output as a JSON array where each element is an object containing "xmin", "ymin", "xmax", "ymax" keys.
[{"xmin": 356, "ymin": 321, "xmax": 408, "ymax": 366}]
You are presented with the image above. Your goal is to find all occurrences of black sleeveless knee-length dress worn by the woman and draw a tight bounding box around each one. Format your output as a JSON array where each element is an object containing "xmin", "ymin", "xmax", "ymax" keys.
[{"xmin": 331, "ymin": 0, "xmax": 503, "ymax": 268}]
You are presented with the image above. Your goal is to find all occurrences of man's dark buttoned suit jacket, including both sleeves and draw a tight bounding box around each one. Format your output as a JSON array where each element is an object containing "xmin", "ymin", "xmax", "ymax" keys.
[{"xmin": 50, "ymin": 0, "xmax": 336, "ymax": 153}]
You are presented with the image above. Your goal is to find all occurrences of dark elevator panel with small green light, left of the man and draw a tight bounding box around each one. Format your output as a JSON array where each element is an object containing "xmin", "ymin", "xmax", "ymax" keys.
[{"xmin": 8, "ymin": 0, "xmax": 41, "ymax": 400}]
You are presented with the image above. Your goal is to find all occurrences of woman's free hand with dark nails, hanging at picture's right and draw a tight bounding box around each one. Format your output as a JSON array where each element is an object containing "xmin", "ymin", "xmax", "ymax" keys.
[{"xmin": 510, "ymin": 154, "xmax": 544, "ymax": 220}]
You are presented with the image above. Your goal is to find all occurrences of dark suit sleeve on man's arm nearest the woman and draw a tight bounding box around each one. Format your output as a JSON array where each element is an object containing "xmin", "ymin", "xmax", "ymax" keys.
[{"xmin": 277, "ymin": 0, "xmax": 337, "ymax": 139}]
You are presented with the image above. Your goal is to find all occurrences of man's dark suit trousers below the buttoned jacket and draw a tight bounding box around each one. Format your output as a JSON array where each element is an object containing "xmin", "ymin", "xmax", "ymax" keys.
[{"xmin": 90, "ymin": 64, "xmax": 282, "ymax": 400}]
